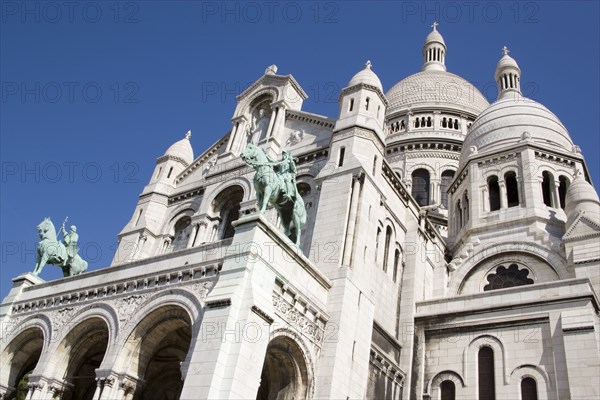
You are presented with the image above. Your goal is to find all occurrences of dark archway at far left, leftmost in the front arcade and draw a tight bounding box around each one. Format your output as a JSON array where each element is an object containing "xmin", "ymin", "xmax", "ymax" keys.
[{"xmin": 0, "ymin": 327, "xmax": 44, "ymax": 399}]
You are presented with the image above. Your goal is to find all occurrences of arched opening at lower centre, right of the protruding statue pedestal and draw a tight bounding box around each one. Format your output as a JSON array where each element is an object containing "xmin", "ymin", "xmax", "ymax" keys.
[{"xmin": 256, "ymin": 336, "xmax": 310, "ymax": 400}]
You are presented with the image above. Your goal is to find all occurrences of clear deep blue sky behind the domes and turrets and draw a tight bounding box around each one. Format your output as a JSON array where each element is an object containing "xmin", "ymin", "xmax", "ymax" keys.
[{"xmin": 0, "ymin": 0, "xmax": 600, "ymax": 298}]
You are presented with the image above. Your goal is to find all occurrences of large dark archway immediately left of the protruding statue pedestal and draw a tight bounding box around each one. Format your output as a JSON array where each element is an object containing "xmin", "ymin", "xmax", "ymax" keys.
[{"xmin": 128, "ymin": 306, "xmax": 192, "ymax": 400}]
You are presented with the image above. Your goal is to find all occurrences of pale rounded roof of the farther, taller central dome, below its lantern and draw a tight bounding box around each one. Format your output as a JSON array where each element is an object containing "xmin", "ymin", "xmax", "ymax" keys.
[{"xmin": 386, "ymin": 69, "xmax": 489, "ymax": 116}]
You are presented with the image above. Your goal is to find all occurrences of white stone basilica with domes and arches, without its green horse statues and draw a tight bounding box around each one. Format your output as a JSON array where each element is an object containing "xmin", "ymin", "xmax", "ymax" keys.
[{"xmin": 0, "ymin": 24, "xmax": 600, "ymax": 400}]
